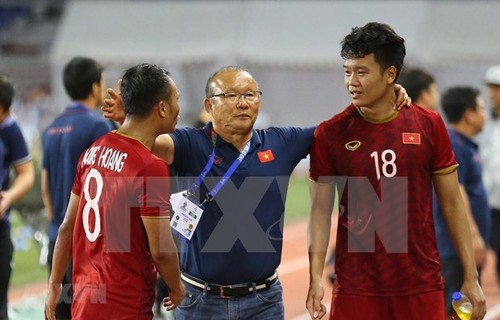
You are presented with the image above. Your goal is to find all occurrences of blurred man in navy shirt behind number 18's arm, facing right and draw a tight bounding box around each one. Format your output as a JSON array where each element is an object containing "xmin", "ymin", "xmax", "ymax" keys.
[{"xmin": 434, "ymin": 87, "xmax": 490, "ymax": 319}]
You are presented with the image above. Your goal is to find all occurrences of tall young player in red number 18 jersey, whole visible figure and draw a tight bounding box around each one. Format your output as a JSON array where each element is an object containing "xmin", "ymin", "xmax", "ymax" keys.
[{"xmin": 306, "ymin": 23, "xmax": 486, "ymax": 320}]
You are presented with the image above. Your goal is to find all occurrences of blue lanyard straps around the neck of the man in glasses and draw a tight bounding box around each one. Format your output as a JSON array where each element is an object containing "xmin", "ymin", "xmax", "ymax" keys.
[{"xmin": 187, "ymin": 133, "xmax": 250, "ymax": 205}]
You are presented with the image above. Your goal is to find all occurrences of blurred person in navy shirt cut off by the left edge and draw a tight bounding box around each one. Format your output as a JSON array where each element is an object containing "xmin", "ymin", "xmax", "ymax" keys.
[{"xmin": 0, "ymin": 76, "xmax": 35, "ymax": 320}]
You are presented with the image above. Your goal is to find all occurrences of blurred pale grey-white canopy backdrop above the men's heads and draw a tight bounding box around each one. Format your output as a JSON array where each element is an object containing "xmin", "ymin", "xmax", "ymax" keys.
[{"xmin": 51, "ymin": 1, "xmax": 500, "ymax": 125}]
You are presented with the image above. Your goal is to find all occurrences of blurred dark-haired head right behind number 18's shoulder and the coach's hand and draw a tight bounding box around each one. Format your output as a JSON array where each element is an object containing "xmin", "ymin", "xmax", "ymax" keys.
[{"xmin": 399, "ymin": 68, "xmax": 439, "ymax": 111}]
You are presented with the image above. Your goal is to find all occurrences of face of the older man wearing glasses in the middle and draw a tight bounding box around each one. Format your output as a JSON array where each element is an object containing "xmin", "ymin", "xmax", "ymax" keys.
[{"xmin": 206, "ymin": 70, "xmax": 260, "ymax": 134}]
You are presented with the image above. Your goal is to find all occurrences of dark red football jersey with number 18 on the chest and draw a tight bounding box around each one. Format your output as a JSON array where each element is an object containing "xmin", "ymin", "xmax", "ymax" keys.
[{"xmin": 310, "ymin": 105, "xmax": 457, "ymax": 296}]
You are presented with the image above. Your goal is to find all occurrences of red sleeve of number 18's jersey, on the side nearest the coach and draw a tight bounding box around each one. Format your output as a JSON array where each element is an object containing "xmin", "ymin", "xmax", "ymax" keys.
[{"xmin": 309, "ymin": 123, "xmax": 334, "ymax": 183}]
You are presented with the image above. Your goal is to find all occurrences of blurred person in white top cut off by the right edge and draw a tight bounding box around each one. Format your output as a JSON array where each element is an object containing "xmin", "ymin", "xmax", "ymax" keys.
[{"xmin": 479, "ymin": 65, "xmax": 500, "ymax": 288}]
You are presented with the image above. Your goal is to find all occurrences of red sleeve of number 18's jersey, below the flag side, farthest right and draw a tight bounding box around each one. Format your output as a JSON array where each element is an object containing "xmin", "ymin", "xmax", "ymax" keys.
[{"xmin": 432, "ymin": 113, "xmax": 458, "ymax": 174}]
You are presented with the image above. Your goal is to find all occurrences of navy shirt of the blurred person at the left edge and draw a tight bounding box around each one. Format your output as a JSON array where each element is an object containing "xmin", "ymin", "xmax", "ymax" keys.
[{"xmin": 0, "ymin": 116, "xmax": 31, "ymax": 229}]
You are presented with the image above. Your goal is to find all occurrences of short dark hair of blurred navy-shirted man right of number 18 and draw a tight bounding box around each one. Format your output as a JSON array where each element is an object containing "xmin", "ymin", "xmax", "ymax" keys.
[{"xmin": 441, "ymin": 86, "xmax": 480, "ymax": 123}]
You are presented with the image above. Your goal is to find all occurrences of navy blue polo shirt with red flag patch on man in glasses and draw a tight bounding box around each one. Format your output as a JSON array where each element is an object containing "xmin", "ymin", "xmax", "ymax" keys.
[{"xmin": 170, "ymin": 123, "xmax": 315, "ymax": 284}]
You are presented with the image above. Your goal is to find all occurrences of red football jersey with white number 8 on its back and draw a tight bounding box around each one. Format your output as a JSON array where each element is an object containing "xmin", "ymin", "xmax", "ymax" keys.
[{"xmin": 72, "ymin": 132, "xmax": 170, "ymax": 319}]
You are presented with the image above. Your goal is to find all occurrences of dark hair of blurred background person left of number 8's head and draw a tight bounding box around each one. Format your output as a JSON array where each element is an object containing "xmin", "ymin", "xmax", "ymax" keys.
[{"xmin": 63, "ymin": 57, "xmax": 104, "ymax": 100}]
